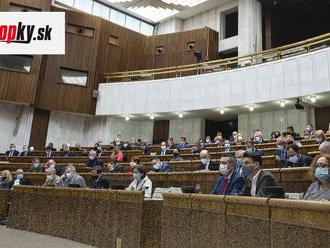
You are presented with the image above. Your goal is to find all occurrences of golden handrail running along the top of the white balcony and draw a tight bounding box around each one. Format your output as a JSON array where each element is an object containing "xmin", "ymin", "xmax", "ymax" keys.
[{"xmin": 99, "ymin": 33, "xmax": 330, "ymax": 82}]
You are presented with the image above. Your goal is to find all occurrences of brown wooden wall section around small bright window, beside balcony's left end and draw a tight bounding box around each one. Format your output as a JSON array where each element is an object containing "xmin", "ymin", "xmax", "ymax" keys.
[{"xmin": 37, "ymin": 7, "xmax": 101, "ymax": 114}]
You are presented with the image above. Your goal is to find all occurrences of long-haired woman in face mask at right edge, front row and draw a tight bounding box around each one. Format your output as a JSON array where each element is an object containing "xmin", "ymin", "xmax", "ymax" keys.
[{"xmin": 304, "ymin": 155, "xmax": 330, "ymax": 201}]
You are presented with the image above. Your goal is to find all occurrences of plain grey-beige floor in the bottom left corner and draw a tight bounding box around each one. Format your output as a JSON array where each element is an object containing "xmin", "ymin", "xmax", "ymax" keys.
[{"xmin": 0, "ymin": 226, "xmax": 94, "ymax": 248}]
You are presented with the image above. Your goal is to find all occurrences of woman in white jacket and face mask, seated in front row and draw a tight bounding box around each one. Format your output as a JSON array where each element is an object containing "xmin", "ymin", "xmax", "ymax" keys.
[{"xmin": 126, "ymin": 164, "xmax": 152, "ymax": 198}]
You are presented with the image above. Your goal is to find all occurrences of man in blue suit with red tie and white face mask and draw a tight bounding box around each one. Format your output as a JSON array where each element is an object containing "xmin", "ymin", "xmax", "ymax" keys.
[{"xmin": 211, "ymin": 157, "xmax": 244, "ymax": 195}]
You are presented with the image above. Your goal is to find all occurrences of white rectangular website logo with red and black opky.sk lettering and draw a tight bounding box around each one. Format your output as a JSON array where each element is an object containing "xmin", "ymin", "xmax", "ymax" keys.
[{"xmin": 0, "ymin": 12, "xmax": 65, "ymax": 54}]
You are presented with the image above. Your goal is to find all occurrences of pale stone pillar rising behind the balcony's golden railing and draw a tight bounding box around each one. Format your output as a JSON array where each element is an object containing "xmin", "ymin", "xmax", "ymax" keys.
[{"xmin": 238, "ymin": 0, "xmax": 262, "ymax": 56}]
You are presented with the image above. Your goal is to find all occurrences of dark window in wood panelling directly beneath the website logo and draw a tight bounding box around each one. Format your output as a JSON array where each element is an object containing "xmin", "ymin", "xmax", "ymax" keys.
[{"xmin": 0, "ymin": 55, "xmax": 33, "ymax": 73}]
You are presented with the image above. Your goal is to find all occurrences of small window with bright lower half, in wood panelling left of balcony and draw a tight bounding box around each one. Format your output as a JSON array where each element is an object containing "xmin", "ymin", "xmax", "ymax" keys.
[{"xmin": 59, "ymin": 67, "xmax": 88, "ymax": 86}]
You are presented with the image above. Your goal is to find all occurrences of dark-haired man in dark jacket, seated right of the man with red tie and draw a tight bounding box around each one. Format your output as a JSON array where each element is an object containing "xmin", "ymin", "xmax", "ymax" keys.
[{"xmin": 239, "ymin": 152, "xmax": 277, "ymax": 197}]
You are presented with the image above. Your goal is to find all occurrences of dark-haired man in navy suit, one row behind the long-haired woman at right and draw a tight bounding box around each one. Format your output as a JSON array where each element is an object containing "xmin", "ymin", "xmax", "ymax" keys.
[{"xmin": 284, "ymin": 145, "xmax": 311, "ymax": 168}]
